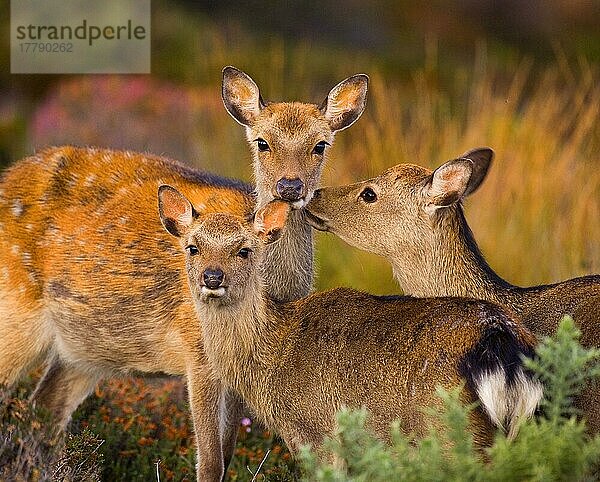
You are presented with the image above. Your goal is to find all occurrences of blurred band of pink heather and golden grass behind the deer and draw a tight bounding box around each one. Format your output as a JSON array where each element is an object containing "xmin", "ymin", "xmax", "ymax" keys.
[{"xmin": 30, "ymin": 48, "xmax": 600, "ymax": 293}]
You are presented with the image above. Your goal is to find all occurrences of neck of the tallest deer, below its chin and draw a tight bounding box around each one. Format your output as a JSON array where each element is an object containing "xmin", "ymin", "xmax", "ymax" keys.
[{"xmin": 262, "ymin": 209, "xmax": 313, "ymax": 301}]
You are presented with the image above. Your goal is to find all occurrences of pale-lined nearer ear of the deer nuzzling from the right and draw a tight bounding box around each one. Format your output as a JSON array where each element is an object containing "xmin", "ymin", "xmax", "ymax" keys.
[{"xmin": 423, "ymin": 158, "xmax": 473, "ymax": 213}]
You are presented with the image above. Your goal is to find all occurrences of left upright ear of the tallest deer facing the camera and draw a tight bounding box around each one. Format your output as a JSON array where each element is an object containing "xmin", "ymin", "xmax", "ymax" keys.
[{"xmin": 221, "ymin": 66, "xmax": 265, "ymax": 126}]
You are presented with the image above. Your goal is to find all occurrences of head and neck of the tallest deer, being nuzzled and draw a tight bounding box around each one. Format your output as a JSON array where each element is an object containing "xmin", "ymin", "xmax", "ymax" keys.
[{"xmin": 222, "ymin": 67, "xmax": 369, "ymax": 301}]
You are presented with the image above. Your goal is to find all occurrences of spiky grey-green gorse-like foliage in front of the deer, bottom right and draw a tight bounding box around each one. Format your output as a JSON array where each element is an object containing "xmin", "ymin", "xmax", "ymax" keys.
[{"xmin": 301, "ymin": 317, "xmax": 600, "ymax": 482}]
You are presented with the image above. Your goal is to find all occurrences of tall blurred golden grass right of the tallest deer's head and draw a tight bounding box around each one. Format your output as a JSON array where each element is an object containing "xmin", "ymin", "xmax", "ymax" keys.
[{"xmin": 319, "ymin": 52, "xmax": 600, "ymax": 292}]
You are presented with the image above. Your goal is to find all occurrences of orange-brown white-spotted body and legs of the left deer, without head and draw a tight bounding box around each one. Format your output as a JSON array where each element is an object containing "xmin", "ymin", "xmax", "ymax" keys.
[{"xmin": 0, "ymin": 147, "xmax": 254, "ymax": 480}]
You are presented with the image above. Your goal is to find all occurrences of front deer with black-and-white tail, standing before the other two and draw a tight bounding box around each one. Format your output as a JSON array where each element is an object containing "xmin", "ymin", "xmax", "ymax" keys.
[{"xmin": 159, "ymin": 186, "xmax": 542, "ymax": 451}]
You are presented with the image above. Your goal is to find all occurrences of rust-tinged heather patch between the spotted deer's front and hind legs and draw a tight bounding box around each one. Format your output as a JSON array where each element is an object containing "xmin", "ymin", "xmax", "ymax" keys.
[{"xmin": 74, "ymin": 379, "xmax": 196, "ymax": 482}]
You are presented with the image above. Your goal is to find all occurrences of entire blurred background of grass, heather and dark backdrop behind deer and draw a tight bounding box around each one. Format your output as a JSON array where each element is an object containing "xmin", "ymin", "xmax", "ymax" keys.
[{"xmin": 0, "ymin": 0, "xmax": 600, "ymax": 293}]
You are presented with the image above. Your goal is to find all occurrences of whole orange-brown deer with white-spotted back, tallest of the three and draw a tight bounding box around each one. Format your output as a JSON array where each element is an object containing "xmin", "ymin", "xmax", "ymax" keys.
[{"xmin": 0, "ymin": 67, "xmax": 366, "ymax": 481}]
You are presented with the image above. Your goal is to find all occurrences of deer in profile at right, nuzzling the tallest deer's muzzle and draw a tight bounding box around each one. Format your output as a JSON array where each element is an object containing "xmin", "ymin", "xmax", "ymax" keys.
[{"xmin": 308, "ymin": 148, "xmax": 600, "ymax": 431}]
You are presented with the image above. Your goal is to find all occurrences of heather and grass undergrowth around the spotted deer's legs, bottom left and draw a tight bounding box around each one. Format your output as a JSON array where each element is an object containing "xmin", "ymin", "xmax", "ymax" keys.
[{"xmin": 0, "ymin": 375, "xmax": 295, "ymax": 482}]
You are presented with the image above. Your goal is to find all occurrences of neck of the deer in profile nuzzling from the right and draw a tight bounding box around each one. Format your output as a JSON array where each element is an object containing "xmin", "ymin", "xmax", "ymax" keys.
[{"xmin": 392, "ymin": 206, "xmax": 513, "ymax": 303}]
